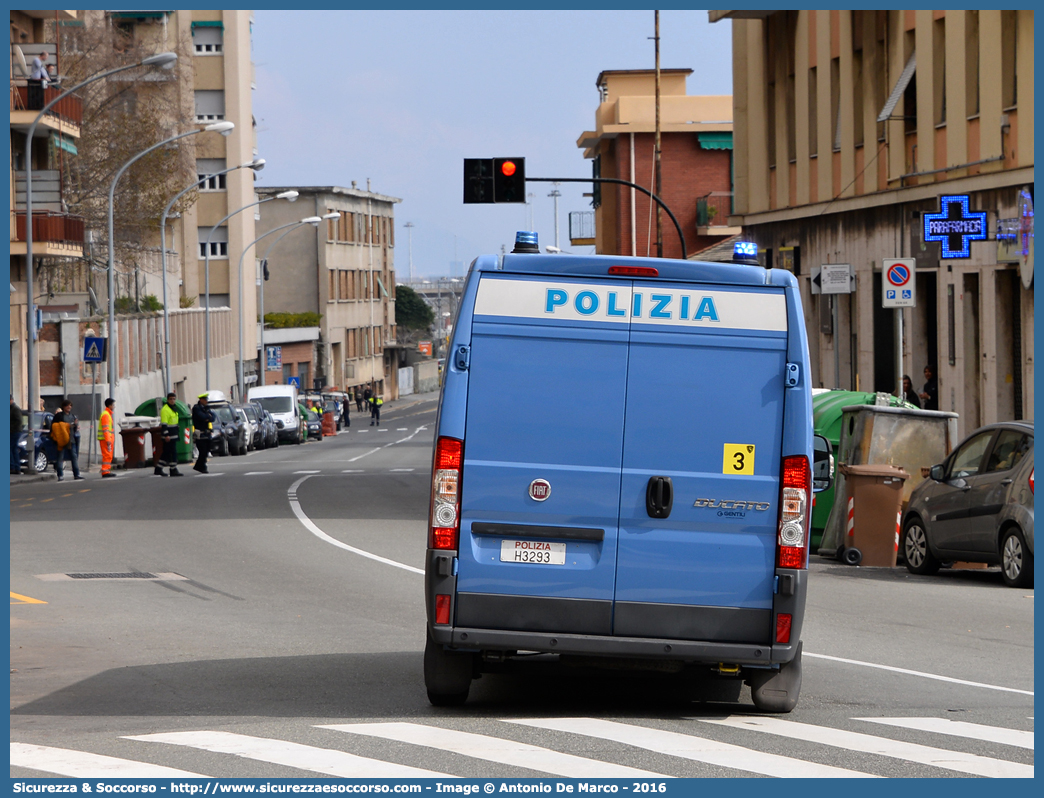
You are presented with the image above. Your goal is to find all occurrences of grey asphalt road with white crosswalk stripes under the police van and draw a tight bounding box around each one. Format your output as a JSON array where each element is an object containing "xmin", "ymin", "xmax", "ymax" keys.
[{"xmin": 10, "ymin": 397, "xmax": 1034, "ymax": 779}]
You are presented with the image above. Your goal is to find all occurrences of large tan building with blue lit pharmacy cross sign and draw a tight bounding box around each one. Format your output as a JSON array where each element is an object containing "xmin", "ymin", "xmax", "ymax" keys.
[{"xmin": 710, "ymin": 10, "xmax": 1034, "ymax": 431}]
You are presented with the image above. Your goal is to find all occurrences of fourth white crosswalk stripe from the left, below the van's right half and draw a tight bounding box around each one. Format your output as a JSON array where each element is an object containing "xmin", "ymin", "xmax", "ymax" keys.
[{"xmin": 502, "ymin": 718, "xmax": 875, "ymax": 778}]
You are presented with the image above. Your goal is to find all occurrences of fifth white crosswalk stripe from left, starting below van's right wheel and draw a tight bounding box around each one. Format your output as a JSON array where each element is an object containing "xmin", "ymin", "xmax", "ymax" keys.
[{"xmin": 693, "ymin": 715, "xmax": 1034, "ymax": 778}]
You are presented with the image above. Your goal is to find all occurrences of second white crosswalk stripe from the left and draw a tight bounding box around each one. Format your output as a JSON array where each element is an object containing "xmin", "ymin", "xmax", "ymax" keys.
[{"xmin": 126, "ymin": 731, "xmax": 453, "ymax": 778}]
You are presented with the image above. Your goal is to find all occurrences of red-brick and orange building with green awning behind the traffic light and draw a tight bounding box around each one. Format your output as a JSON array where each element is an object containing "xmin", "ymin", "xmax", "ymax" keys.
[{"xmin": 570, "ymin": 69, "xmax": 738, "ymax": 258}]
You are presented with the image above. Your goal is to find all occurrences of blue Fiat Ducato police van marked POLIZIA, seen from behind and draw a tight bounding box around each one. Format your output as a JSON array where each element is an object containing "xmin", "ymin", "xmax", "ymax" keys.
[{"xmin": 424, "ymin": 234, "xmax": 828, "ymax": 712}]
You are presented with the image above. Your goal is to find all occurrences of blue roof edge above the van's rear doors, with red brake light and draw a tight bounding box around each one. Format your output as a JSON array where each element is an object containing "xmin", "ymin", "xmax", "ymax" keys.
[{"xmin": 484, "ymin": 254, "xmax": 778, "ymax": 285}]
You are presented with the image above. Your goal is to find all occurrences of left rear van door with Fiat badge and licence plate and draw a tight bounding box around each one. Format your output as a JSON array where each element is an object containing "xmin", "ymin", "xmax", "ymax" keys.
[{"xmin": 455, "ymin": 274, "xmax": 631, "ymax": 635}]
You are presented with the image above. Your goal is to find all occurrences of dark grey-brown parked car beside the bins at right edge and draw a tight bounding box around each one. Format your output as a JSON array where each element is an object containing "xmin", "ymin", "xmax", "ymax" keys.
[{"xmin": 900, "ymin": 421, "xmax": 1034, "ymax": 588}]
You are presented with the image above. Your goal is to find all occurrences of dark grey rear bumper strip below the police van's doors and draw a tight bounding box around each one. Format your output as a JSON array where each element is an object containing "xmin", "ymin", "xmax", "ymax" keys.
[{"xmin": 429, "ymin": 626, "xmax": 798, "ymax": 665}]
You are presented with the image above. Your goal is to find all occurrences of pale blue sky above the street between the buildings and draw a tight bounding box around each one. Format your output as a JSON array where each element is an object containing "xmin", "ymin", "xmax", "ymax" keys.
[{"xmin": 253, "ymin": 9, "xmax": 732, "ymax": 280}]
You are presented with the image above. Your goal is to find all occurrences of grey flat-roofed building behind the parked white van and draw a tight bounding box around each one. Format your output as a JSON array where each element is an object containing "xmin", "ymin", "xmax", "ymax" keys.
[{"xmin": 252, "ymin": 184, "xmax": 402, "ymax": 400}]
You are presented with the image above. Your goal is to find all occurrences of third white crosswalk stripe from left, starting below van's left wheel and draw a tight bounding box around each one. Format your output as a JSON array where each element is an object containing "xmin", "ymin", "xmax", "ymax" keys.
[{"xmin": 318, "ymin": 723, "xmax": 672, "ymax": 778}]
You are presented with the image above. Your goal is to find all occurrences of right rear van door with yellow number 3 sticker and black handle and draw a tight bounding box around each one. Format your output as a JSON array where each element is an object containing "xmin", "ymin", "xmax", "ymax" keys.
[{"xmin": 613, "ymin": 282, "xmax": 787, "ymax": 643}]
